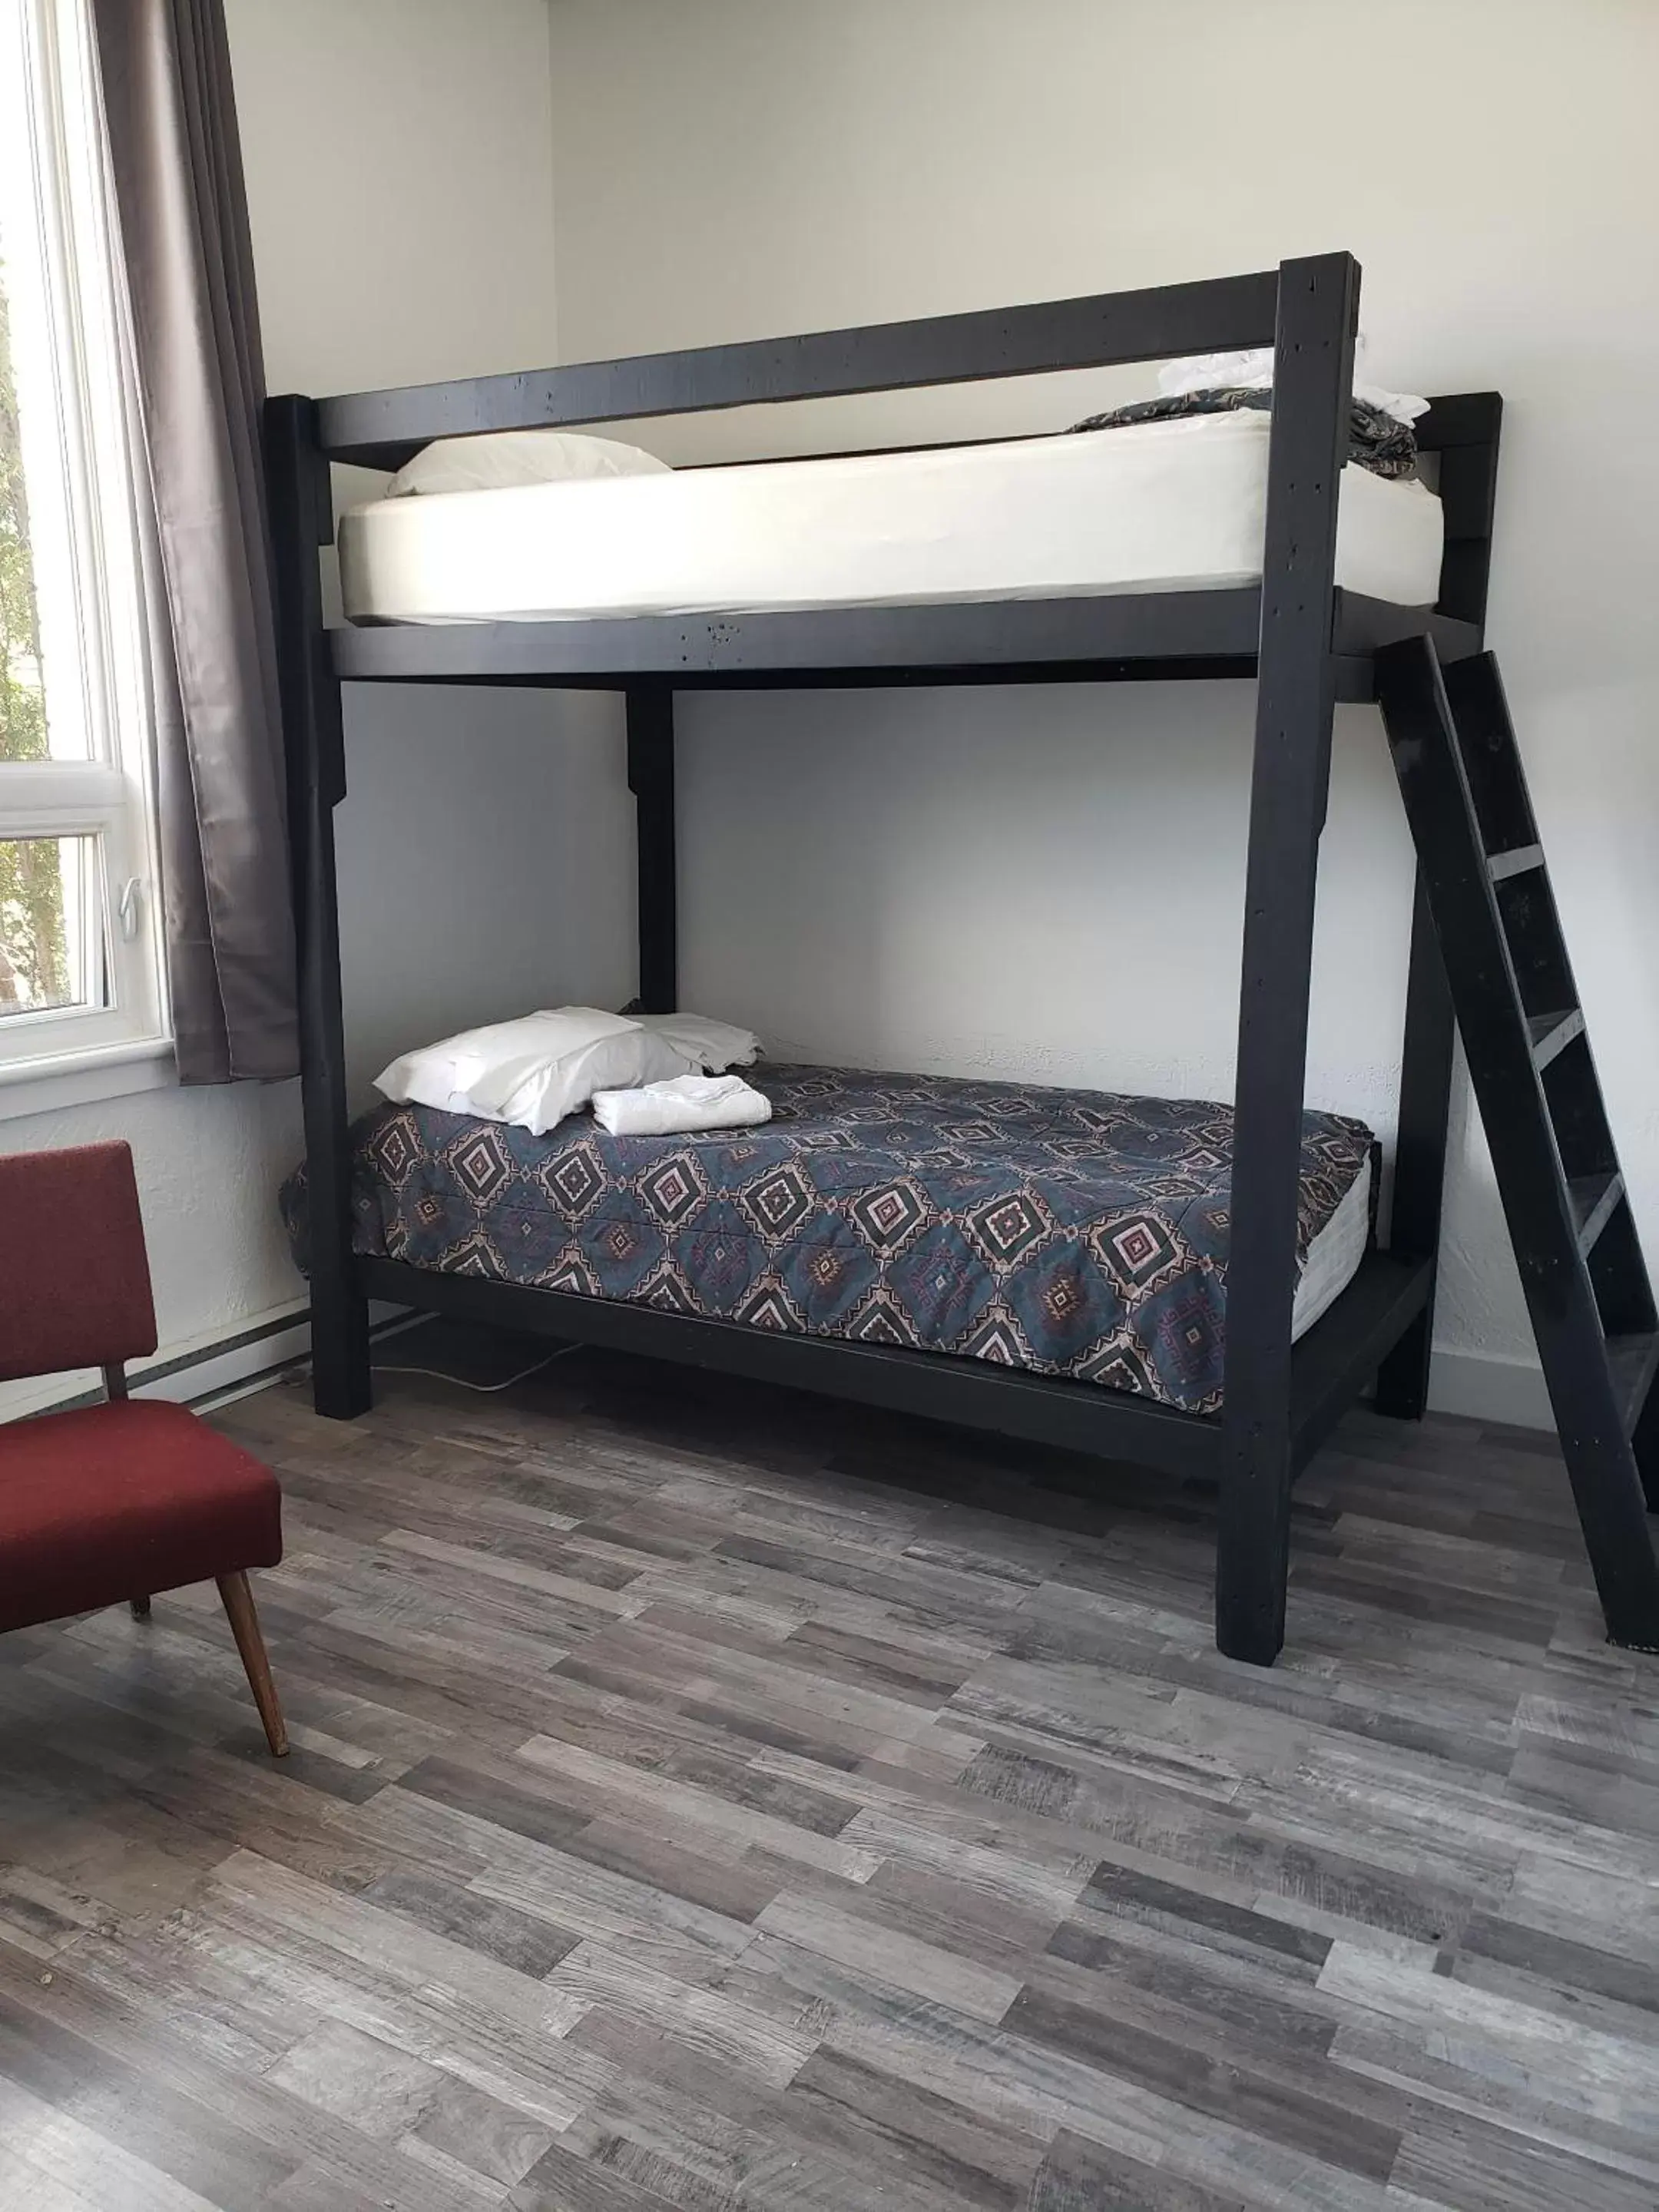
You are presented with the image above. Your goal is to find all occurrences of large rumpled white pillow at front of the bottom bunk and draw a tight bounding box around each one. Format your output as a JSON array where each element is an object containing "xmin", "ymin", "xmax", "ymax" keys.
[{"xmin": 374, "ymin": 1006, "xmax": 697, "ymax": 1137}]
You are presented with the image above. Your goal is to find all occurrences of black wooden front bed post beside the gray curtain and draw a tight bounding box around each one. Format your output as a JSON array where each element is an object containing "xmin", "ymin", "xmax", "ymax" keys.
[{"xmin": 266, "ymin": 396, "xmax": 369, "ymax": 1420}]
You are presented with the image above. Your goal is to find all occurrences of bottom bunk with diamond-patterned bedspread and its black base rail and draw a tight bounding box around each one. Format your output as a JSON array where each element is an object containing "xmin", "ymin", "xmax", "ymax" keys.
[{"xmin": 283, "ymin": 1066, "xmax": 1429, "ymax": 1469}]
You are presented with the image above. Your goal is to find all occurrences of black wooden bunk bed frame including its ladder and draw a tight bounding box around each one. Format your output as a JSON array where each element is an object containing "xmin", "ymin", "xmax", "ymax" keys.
[{"xmin": 266, "ymin": 254, "xmax": 1659, "ymax": 1664}]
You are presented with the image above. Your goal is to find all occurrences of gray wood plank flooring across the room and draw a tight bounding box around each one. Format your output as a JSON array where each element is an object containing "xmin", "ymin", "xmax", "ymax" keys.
[{"xmin": 0, "ymin": 1327, "xmax": 1659, "ymax": 2212}]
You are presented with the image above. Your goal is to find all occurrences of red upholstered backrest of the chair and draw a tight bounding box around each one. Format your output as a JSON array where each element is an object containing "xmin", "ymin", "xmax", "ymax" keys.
[{"xmin": 0, "ymin": 1144, "xmax": 155, "ymax": 1380}]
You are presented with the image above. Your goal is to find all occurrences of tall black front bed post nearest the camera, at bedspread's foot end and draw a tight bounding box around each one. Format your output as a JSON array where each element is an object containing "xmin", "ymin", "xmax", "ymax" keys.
[{"xmin": 1217, "ymin": 254, "xmax": 1360, "ymax": 1666}]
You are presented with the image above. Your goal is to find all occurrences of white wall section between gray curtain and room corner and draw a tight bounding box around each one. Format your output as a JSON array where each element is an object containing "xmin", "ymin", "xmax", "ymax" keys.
[{"xmin": 228, "ymin": 0, "xmax": 633, "ymax": 1099}]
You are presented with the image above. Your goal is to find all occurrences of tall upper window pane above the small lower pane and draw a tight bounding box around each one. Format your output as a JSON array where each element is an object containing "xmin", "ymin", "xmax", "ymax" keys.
[{"xmin": 0, "ymin": 208, "xmax": 86, "ymax": 763}]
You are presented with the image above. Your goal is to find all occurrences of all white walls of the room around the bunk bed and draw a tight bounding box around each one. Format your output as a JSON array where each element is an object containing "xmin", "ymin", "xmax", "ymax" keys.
[{"xmin": 16, "ymin": 0, "xmax": 1659, "ymax": 1416}]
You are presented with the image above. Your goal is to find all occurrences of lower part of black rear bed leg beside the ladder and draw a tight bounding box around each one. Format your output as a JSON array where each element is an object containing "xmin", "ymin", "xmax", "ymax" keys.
[{"xmin": 1376, "ymin": 869, "xmax": 1458, "ymax": 1420}]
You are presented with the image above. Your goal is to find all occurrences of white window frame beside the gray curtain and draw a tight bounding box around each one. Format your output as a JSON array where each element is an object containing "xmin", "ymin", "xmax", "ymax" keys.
[{"xmin": 0, "ymin": 0, "xmax": 171, "ymax": 1117}]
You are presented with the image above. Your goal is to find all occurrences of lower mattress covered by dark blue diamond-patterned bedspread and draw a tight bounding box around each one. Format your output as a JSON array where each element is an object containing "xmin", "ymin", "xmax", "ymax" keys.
[{"xmin": 283, "ymin": 1066, "xmax": 1373, "ymax": 1413}]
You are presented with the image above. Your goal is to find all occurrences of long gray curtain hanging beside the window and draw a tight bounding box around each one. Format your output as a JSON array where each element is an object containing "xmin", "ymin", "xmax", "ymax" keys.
[{"xmin": 91, "ymin": 0, "xmax": 299, "ymax": 1084}]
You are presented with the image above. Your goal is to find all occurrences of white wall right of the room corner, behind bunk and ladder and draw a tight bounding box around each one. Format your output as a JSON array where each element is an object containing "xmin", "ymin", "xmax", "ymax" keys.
[{"xmin": 551, "ymin": 0, "xmax": 1659, "ymax": 1418}]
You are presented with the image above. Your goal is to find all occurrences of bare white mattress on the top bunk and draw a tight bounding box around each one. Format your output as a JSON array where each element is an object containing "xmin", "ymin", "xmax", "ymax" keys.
[{"xmin": 339, "ymin": 412, "xmax": 1442, "ymax": 621}]
